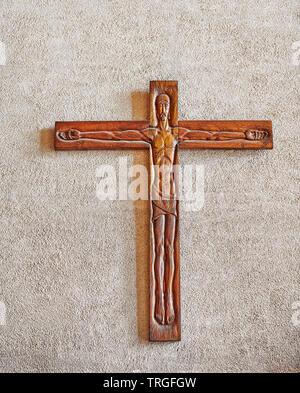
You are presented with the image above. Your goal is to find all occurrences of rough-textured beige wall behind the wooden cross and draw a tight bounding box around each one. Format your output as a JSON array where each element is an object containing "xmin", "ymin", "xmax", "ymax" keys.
[{"xmin": 0, "ymin": 0, "xmax": 300, "ymax": 372}]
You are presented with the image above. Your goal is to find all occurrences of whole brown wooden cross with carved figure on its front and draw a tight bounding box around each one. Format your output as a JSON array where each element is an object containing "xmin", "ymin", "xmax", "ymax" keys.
[{"xmin": 55, "ymin": 81, "xmax": 273, "ymax": 341}]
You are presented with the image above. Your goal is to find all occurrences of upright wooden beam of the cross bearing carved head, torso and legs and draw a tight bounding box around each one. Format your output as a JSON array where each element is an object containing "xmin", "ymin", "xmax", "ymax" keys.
[{"xmin": 150, "ymin": 81, "xmax": 181, "ymax": 341}]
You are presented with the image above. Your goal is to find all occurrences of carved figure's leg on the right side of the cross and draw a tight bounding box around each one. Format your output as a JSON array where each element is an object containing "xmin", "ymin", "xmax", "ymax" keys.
[{"xmin": 165, "ymin": 214, "xmax": 176, "ymax": 325}]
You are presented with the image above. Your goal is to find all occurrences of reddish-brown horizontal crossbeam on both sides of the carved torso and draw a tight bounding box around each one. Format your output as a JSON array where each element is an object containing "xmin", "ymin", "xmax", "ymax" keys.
[{"xmin": 55, "ymin": 120, "xmax": 273, "ymax": 150}]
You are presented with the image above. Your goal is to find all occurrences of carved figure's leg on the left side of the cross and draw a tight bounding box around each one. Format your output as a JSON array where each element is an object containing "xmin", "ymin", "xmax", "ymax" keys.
[{"xmin": 153, "ymin": 216, "xmax": 165, "ymax": 325}]
